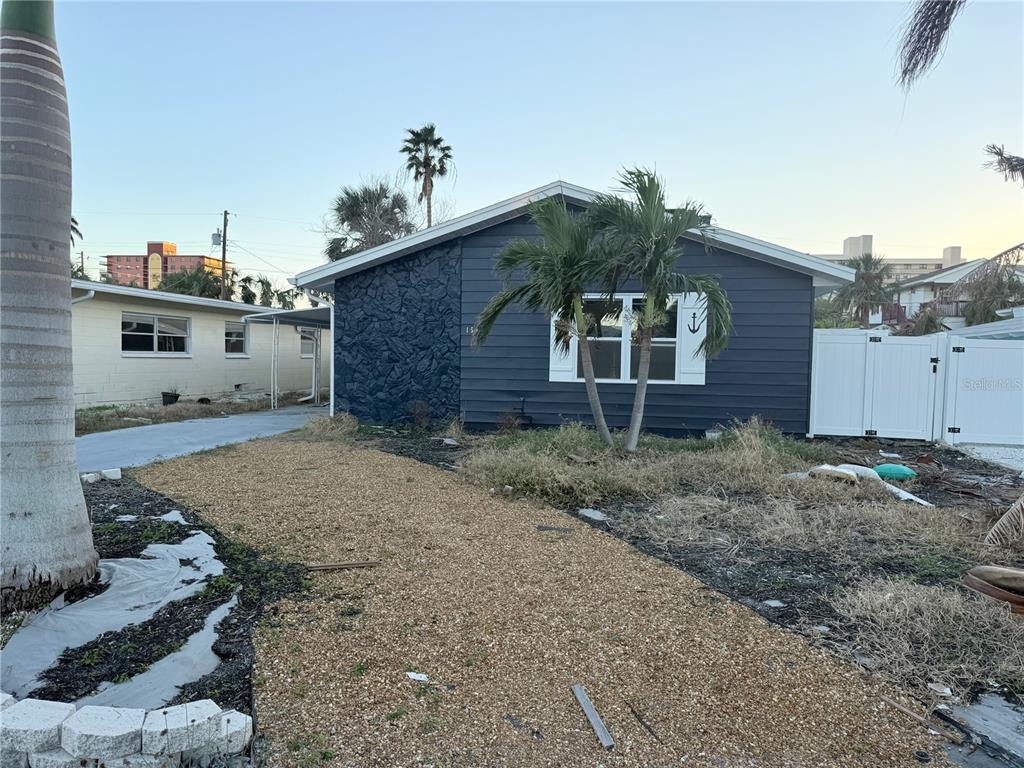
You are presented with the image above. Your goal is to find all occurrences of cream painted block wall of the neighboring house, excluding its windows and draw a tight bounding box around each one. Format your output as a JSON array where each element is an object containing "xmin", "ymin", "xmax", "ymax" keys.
[{"xmin": 72, "ymin": 293, "xmax": 331, "ymax": 408}]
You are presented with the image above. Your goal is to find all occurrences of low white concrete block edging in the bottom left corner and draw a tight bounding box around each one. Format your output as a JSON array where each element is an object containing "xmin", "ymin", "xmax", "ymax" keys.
[{"xmin": 0, "ymin": 693, "xmax": 253, "ymax": 768}]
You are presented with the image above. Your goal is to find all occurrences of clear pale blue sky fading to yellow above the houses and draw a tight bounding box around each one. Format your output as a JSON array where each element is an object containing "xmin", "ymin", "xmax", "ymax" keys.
[{"xmin": 57, "ymin": 2, "xmax": 1024, "ymax": 281}]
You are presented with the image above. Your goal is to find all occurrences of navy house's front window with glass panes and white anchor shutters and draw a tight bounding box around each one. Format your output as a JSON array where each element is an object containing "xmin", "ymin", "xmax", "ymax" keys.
[{"xmin": 548, "ymin": 294, "xmax": 707, "ymax": 385}]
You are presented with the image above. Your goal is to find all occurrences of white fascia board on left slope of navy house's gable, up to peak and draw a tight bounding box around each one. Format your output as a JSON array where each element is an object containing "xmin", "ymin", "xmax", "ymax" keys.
[{"xmin": 292, "ymin": 181, "xmax": 597, "ymax": 288}]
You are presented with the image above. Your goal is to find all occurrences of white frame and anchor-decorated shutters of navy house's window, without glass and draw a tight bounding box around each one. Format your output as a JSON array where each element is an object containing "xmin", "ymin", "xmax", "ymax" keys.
[{"xmin": 548, "ymin": 293, "xmax": 707, "ymax": 386}]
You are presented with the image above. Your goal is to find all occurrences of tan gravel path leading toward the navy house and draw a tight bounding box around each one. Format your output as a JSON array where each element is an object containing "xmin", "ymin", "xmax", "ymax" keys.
[{"xmin": 138, "ymin": 438, "xmax": 942, "ymax": 766}]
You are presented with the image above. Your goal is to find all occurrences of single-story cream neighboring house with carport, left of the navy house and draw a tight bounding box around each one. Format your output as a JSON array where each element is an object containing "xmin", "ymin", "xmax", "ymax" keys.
[{"xmin": 72, "ymin": 280, "xmax": 331, "ymax": 407}]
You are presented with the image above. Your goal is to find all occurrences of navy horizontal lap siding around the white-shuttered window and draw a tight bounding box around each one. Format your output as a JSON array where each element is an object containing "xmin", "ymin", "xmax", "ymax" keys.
[{"xmin": 461, "ymin": 217, "xmax": 813, "ymax": 434}]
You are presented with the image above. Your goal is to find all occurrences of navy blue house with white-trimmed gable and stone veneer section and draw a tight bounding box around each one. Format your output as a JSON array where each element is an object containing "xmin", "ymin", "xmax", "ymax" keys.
[{"xmin": 296, "ymin": 181, "xmax": 853, "ymax": 434}]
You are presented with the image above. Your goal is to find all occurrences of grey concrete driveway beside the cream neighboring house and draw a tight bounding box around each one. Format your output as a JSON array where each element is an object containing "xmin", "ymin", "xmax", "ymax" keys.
[{"xmin": 75, "ymin": 406, "xmax": 317, "ymax": 472}]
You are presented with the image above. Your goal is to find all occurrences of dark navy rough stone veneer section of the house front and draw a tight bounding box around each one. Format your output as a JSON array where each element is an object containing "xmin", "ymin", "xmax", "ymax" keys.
[{"xmin": 334, "ymin": 242, "xmax": 462, "ymax": 423}]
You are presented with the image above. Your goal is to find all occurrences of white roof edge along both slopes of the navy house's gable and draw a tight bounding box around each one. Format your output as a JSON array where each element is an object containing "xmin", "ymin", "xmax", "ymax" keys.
[{"xmin": 291, "ymin": 181, "xmax": 855, "ymax": 289}]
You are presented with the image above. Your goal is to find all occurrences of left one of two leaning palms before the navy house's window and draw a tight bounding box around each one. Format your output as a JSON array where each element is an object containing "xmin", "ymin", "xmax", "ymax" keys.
[{"xmin": 475, "ymin": 198, "xmax": 613, "ymax": 447}]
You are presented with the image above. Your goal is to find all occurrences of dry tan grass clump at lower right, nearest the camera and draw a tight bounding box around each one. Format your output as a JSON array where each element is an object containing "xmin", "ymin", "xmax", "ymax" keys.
[{"xmin": 833, "ymin": 579, "xmax": 1024, "ymax": 694}]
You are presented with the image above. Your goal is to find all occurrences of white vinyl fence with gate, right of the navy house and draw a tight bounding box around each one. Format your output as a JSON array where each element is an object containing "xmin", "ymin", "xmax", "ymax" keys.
[{"xmin": 809, "ymin": 329, "xmax": 1024, "ymax": 445}]
